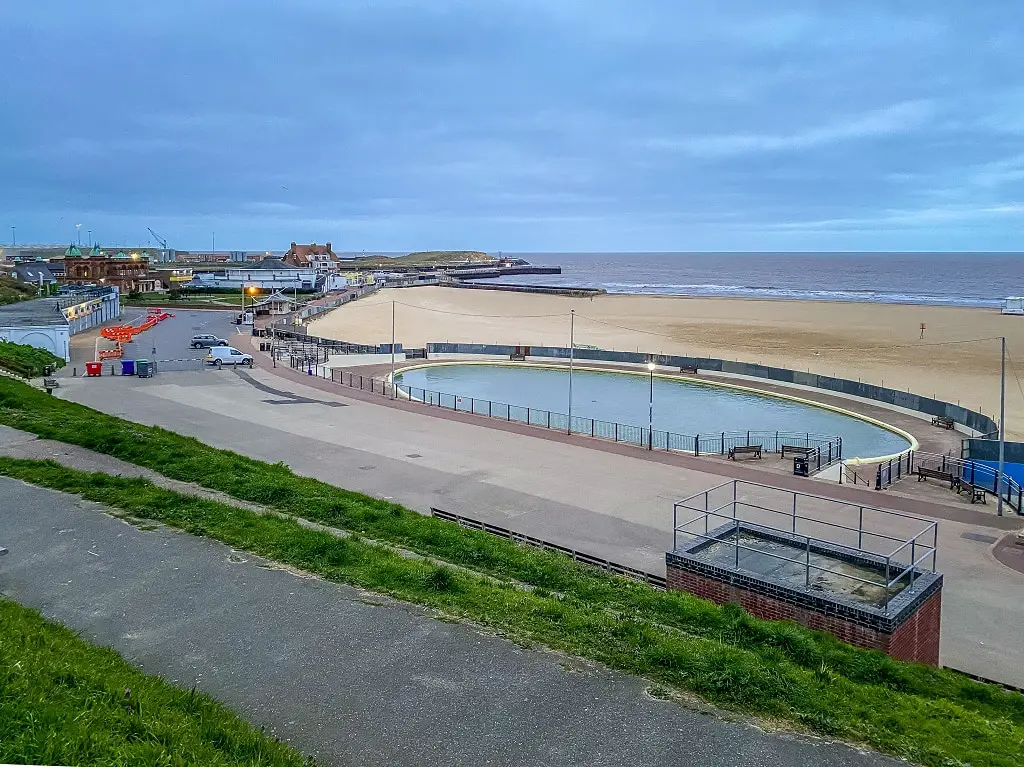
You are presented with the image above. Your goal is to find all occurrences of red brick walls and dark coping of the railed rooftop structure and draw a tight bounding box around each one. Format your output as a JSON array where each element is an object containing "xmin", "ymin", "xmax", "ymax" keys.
[{"xmin": 665, "ymin": 523, "xmax": 942, "ymax": 666}]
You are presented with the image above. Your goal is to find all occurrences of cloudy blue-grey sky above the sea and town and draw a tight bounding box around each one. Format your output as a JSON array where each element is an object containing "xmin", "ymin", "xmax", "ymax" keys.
[{"xmin": 0, "ymin": 0, "xmax": 1024, "ymax": 252}]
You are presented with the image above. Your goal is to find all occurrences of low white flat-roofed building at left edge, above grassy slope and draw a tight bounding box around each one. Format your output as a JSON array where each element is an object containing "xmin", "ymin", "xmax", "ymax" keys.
[{"xmin": 0, "ymin": 287, "xmax": 121, "ymax": 361}]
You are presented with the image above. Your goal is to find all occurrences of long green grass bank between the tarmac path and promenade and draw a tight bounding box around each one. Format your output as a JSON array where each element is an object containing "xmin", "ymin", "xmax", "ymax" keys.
[{"xmin": 0, "ymin": 380, "xmax": 1024, "ymax": 765}]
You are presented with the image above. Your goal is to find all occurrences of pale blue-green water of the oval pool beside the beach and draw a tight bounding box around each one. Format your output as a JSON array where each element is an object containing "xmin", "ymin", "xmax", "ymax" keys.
[{"xmin": 396, "ymin": 364, "xmax": 909, "ymax": 458}]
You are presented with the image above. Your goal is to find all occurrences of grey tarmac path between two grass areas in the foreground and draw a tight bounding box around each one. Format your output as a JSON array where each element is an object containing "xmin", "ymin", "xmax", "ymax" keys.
[{"xmin": 0, "ymin": 478, "xmax": 897, "ymax": 767}]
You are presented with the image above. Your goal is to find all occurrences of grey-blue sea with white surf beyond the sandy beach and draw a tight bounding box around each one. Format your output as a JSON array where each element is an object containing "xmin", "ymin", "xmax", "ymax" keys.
[{"xmin": 502, "ymin": 253, "xmax": 1024, "ymax": 307}]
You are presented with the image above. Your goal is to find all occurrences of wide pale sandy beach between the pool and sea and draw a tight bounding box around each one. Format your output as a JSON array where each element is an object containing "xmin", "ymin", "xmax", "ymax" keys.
[{"xmin": 309, "ymin": 288, "xmax": 1024, "ymax": 439}]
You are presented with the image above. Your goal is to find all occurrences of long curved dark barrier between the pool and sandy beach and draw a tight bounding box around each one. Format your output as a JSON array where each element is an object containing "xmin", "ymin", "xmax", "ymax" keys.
[{"xmin": 427, "ymin": 343, "xmax": 998, "ymax": 434}]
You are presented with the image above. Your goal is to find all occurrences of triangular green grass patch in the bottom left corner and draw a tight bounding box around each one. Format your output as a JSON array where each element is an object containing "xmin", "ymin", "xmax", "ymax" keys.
[{"xmin": 0, "ymin": 598, "xmax": 307, "ymax": 767}]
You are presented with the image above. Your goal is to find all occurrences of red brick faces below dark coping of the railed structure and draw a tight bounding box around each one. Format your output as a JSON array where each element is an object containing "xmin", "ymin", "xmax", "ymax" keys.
[{"xmin": 666, "ymin": 563, "xmax": 942, "ymax": 666}]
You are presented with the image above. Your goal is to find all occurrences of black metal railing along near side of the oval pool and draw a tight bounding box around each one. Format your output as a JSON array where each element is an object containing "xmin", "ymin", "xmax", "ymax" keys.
[{"xmin": 316, "ymin": 367, "xmax": 843, "ymax": 472}]
